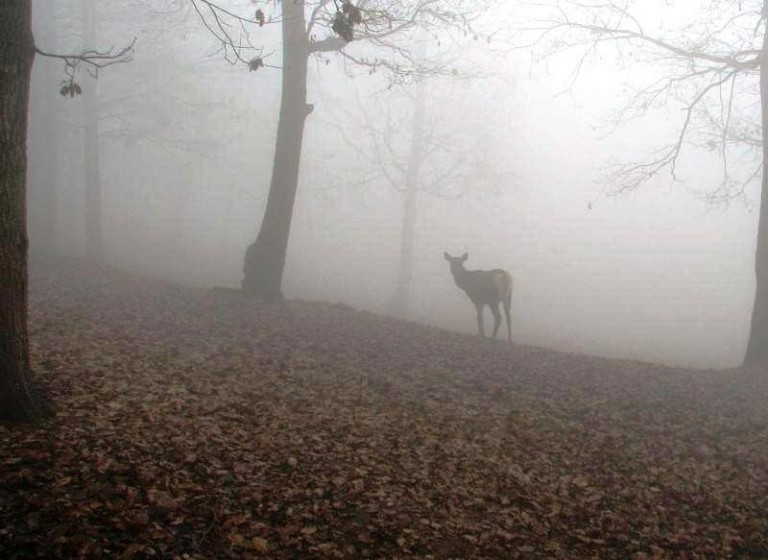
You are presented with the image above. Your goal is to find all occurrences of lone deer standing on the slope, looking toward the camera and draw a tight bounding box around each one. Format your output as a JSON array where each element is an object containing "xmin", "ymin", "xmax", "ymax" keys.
[{"xmin": 443, "ymin": 252, "xmax": 512, "ymax": 342}]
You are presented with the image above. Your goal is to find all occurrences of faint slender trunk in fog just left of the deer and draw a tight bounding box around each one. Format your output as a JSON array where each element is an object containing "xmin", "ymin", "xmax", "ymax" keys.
[{"xmin": 390, "ymin": 80, "xmax": 427, "ymax": 317}]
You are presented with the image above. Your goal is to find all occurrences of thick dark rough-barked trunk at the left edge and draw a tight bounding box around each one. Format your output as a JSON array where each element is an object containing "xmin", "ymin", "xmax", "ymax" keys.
[{"xmin": 0, "ymin": 0, "xmax": 38, "ymax": 420}]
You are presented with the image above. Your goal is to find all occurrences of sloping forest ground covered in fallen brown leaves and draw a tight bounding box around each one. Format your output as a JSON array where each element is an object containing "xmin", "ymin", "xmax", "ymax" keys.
[{"xmin": 0, "ymin": 262, "xmax": 768, "ymax": 559}]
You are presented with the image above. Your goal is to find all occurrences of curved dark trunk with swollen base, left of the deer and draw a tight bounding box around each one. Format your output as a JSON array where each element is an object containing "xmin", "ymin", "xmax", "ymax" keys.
[{"xmin": 242, "ymin": 0, "xmax": 312, "ymax": 303}]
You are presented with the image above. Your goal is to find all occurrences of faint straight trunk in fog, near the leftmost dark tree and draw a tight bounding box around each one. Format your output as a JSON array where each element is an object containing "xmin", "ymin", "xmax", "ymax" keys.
[{"xmin": 80, "ymin": 0, "xmax": 104, "ymax": 262}]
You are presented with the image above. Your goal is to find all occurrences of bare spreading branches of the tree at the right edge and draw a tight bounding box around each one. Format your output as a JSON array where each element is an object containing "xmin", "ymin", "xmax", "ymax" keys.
[{"xmin": 515, "ymin": 0, "xmax": 765, "ymax": 197}]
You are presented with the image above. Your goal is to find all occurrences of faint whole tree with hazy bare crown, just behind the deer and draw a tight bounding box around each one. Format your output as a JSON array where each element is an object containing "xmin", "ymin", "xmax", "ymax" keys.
[{"xmin": 330, "ymin": 73, "xmax": 510, "ymax": 317}]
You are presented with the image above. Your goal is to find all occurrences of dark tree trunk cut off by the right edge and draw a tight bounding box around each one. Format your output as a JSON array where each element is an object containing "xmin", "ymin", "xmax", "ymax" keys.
[{"xmin": 744, "ymin": 15, "xmax": 768, "ymax": 367}]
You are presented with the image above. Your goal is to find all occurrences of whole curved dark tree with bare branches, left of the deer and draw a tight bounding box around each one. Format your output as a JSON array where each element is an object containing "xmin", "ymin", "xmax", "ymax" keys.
[{"xmin": 189, "ymin": 0, "xmax": 481, "ymax": 302}]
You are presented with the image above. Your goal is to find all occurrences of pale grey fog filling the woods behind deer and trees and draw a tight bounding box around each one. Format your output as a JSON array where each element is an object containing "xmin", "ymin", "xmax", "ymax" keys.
[{"xmin": 28, "ymin": 0, "xmax": 759, "ymax": 368}]
